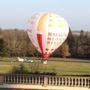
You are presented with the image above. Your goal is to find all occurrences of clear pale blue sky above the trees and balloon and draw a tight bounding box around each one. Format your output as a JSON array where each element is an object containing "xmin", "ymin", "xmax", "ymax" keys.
[{"xmin": 0, "ymin": 0, "xmax": 90, "ymax": 31}]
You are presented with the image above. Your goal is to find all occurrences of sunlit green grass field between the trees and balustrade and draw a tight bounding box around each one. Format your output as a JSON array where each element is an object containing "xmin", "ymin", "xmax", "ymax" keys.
[{"xmin": 0, "ymin": 57, "xmax": 90, "ymax": 75}]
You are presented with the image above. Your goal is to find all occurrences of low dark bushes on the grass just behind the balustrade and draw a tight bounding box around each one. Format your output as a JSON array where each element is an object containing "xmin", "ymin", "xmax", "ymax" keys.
[{"xmin": 9, "ymin": 64, "xmax": 56, "ymax": 75}]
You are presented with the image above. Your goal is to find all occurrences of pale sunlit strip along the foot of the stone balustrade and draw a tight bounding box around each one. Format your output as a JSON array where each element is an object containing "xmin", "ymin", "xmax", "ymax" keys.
[{"xmin": 0, "ymin": 84, "xmax": 90, "ymax": 90}]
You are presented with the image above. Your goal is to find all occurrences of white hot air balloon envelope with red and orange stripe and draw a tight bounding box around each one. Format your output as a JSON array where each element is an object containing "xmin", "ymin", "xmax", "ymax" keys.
[{"xmin": 27, "ymin": 12, "xmax": 69, "ymax": 59}]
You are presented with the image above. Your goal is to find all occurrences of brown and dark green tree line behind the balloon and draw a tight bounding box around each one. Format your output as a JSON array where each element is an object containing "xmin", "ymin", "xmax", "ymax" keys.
[{"xmin": 0, "ymin": 28, "xmax": 90, "ymax": 59}]
